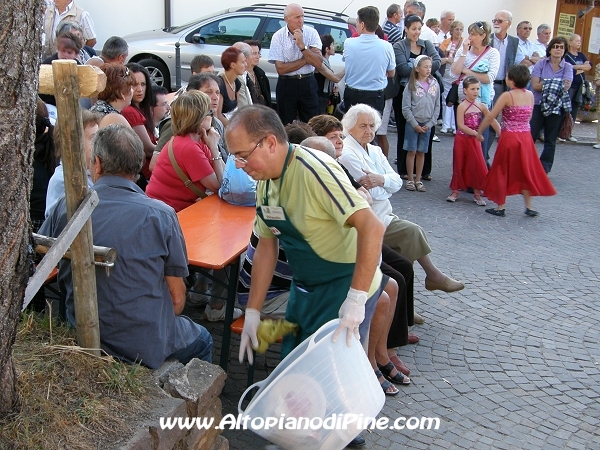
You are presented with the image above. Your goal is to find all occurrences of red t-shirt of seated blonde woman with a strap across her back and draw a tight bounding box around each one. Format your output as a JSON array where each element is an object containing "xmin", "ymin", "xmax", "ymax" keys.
[{"xmin": 146, "ymin": 135, "xmax": 214, "ymax": 211}]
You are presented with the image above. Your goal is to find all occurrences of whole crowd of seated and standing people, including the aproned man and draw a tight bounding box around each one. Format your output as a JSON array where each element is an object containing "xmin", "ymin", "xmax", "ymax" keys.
[{"xmin": 31, "ymin": 0, "xmax": 591, "ymax": 445}]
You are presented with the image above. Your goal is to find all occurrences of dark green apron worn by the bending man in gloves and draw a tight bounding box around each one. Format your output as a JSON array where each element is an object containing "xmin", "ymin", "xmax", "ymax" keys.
[{"xmin": 256, "ymin": 145, "xmax": 355, "ymax": 358}]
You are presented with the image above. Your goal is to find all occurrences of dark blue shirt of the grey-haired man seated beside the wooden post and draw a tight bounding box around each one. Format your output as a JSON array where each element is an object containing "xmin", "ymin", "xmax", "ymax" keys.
[{"xmin": 40, "ymin": 175, "xmax": 200, "ymax": 369}]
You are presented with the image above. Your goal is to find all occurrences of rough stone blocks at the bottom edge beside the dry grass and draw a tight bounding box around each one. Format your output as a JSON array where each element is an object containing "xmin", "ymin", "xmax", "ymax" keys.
[{"xmin": 120, "ymin": 359, "xmax": 229, "ymax": 450}]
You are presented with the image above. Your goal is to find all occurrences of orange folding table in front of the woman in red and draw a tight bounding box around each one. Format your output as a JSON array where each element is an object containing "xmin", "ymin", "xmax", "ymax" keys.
[{"xmin": 177, "ymin": 195, "xmax": 256, "ymax": 371}]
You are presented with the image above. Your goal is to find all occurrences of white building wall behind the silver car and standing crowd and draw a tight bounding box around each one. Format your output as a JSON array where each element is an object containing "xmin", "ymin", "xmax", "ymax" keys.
[{"xmin": 76, "ymin": 0, "xmax": 556, "ymax": 49}]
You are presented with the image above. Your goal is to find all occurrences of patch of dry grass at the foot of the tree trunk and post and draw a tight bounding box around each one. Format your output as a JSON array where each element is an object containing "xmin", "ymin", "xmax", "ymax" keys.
[{"xmin": 0, "ymin": 314, "xmax": 154, "ymax": 450}]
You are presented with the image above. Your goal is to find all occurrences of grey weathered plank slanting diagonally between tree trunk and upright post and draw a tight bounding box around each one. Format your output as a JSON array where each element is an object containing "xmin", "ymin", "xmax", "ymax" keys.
[{"xmin": 22, "ymin": 191, "xmax": 98, "ymax": 310}]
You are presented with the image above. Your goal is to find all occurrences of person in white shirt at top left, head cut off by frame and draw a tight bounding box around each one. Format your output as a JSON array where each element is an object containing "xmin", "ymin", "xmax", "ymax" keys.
[{"xmin": 42, "ymin": 0, "xmax": 96, "ymax": 59}]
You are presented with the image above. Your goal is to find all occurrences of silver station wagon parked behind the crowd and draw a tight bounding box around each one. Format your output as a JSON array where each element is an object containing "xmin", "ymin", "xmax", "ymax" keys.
[{"xmin": 125, "ymin": 3, "xmax": 356, "ymax": 99}]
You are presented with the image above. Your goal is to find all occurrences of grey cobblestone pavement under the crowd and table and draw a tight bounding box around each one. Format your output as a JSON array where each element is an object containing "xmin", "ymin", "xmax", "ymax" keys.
[{"xmin": 190, "ymin": 124, "xmax": 600, "ymax": 449}]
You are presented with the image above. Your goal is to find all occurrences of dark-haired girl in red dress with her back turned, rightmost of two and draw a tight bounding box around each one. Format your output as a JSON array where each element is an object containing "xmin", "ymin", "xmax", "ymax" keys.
[{"xmin": 477, "ymin": 65, "xmax": 556, "ymax": 217}]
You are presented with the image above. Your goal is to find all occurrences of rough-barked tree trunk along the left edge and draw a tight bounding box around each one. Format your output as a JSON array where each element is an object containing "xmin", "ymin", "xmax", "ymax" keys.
[{"xmin": 0, "ymin": 0, "xmax": 43, "ymax": 416}]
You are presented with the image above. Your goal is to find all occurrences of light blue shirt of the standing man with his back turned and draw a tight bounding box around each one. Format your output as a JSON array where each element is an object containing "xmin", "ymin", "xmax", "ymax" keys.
[{"xmin": 343, "ymin": 34, "xmax": 396, "ymax": 91}]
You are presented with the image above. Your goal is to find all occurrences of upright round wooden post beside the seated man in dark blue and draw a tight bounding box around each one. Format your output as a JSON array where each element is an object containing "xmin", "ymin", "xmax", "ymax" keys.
[{"xmin": 52, "ymin": 60, "xmax": 100, "ymax": 355}]
